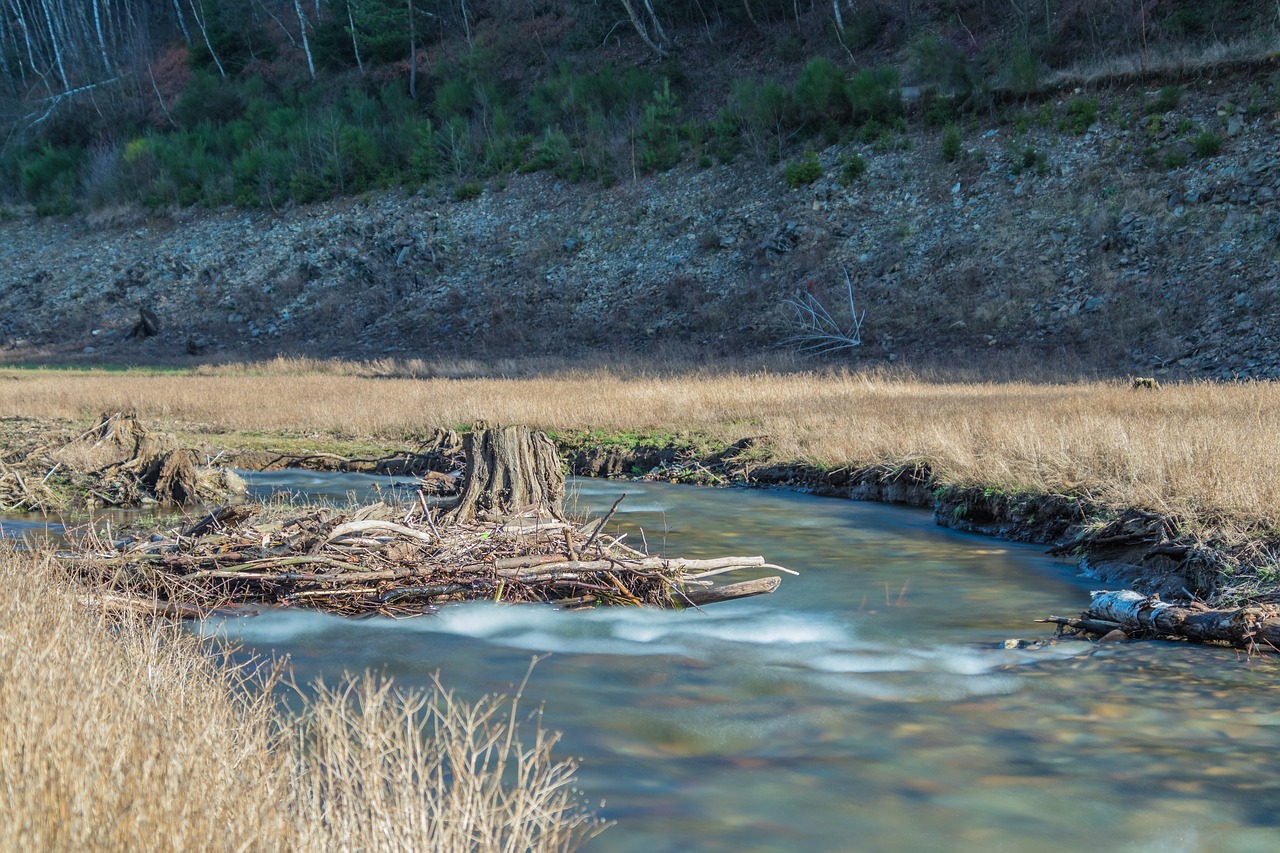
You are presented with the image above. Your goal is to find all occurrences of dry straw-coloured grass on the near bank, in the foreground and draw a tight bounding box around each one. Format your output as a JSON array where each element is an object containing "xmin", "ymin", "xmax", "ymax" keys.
[{"xmin": 0, "ymin": 547, "xmax": 598, "ymax": 850}]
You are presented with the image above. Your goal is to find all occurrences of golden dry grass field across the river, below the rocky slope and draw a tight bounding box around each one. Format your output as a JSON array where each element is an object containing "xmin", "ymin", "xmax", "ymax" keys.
[{"xmin": 0, "ymin": 360, "xmax": 1280, "ymax": 530}]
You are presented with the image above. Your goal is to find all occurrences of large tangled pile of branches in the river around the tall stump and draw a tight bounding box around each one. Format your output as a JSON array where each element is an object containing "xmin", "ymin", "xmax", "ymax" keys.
[{"xmin": 63, "ymin": 496, "xmax": 795, "ymax": 616}]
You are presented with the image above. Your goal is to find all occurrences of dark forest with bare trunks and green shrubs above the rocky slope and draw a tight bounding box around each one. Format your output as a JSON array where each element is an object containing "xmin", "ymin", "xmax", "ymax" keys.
[{"xmin": 0, "ymin": 0, "xmax": 1280, "ymax": 214}]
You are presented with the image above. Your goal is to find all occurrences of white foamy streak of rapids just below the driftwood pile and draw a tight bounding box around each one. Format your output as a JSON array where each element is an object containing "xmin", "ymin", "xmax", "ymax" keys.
[{"xmin": 215, "ymin": 602, "xmax": 1088, "ymax": 698}]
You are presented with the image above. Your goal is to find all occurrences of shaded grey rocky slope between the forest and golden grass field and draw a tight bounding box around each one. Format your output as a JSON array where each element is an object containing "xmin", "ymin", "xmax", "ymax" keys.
[{"xmin": 0, "ymin": 73, "xmax": 1280, "ymax": 379}]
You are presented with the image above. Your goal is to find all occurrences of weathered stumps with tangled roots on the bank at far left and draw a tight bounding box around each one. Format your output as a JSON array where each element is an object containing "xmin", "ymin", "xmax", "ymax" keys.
[{"xmin": 0, "ymin": 412, "xmax": 244, "ymax": 512}]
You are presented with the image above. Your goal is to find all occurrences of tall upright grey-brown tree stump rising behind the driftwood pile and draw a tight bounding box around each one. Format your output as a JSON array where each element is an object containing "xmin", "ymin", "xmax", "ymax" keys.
[{"xmin": 444, "ymin": 424, "xmax": 564, "ymax": 524}]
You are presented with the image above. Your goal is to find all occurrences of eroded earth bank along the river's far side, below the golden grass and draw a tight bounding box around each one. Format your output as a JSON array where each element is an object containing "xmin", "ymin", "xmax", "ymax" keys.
[{"xmin": 0, "ymin": 407, "xmax": 1280, "ymax": 614}]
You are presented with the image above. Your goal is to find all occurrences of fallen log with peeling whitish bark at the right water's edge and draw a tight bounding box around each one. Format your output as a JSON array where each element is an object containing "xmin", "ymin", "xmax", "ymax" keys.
[{"xmin": 1043, "ymin": 589, "xmax": 1280, "ymax": 651}]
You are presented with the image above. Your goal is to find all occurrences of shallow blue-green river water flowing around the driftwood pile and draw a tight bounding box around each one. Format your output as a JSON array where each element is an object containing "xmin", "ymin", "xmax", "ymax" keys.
[{"xmin": 7, "ymin": 473, "xmax": 1280, "ymax": 853}]
